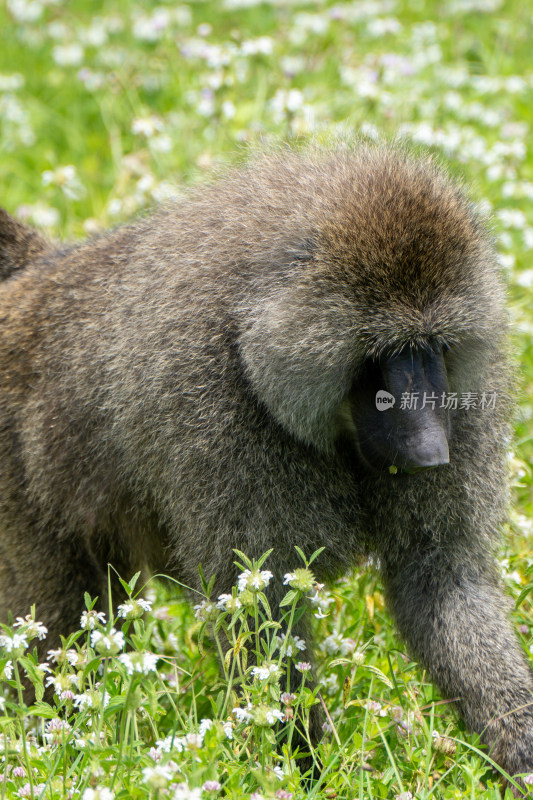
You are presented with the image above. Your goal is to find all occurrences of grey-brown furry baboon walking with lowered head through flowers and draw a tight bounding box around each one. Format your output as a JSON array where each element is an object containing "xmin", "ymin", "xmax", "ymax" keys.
[{"xmin": 0, "ymin": 145, "xmax": 533, "ymax": 775}]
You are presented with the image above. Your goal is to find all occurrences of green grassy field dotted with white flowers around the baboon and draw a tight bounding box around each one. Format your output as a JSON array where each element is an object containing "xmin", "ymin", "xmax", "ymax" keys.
[{"xmin": 0, "ymin": 0, "xmax": 533, "ymax": 800}]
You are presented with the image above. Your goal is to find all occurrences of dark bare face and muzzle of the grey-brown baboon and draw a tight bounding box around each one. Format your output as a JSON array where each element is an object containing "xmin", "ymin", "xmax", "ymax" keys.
[{"xmin": 350, "ymin": 343, "xmax": 450, "ymax": 472}]
